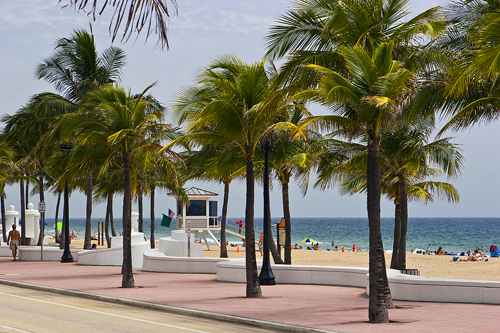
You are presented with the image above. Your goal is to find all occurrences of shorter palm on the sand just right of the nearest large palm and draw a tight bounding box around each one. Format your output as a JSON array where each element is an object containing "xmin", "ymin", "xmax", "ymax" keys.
[{"xmin": 381, "ymin": 117, "xmax": 463, "ymax": 269}]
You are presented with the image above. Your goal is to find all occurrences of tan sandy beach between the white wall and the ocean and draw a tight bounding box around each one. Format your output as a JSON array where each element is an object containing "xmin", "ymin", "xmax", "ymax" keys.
[{"xmin": 49, "ymin": 239, "xmax": 500, "ymax": 281}]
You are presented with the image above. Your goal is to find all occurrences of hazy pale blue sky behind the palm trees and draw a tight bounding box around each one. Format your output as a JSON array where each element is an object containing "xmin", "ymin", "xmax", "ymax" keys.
[{"xmin": 0, "ymin": 0, "xmax": 500, "ymax": 218}]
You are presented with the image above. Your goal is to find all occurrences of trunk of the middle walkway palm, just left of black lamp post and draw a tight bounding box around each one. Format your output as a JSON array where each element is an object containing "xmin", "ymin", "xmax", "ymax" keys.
[{"xmin": 245, "ymin": 157, "xmax": 262, "ymax": 298}]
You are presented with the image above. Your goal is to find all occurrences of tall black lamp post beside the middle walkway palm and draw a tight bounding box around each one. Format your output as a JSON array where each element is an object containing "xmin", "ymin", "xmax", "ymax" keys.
[{"xmin": 259, "ymin": 136, "xmax": 276, "ymax": 286}]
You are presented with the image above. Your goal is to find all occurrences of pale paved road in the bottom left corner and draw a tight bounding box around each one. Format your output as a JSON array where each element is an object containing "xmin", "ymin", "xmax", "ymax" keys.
[{"xmin": 0, "ymin": 285, "xmax": 270, "ymax": 333}]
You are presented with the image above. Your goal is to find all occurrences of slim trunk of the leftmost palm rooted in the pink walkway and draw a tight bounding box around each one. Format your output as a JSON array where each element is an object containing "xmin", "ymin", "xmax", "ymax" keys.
[{"xmin": 122, "ymin": 155, "xmax": 135, "ymax": 288}]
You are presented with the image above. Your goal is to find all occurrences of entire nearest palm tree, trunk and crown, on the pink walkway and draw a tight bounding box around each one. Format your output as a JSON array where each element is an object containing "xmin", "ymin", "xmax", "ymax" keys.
[{"xmin": 301, "ymin": 42, "xmax": 412, "ymax": 322}]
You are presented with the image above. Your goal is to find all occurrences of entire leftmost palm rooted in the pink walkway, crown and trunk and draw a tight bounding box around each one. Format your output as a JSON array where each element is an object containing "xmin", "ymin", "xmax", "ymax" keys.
[{"xmin": 63, "ymin": 86, "xmax": 170, "ymax": 288}]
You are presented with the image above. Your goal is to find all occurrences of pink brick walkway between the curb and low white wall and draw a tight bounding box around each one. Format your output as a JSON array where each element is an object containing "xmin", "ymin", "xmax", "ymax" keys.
[{"xmin": 0, "ymin": 258, "xmax": 500, "ymax": 333}]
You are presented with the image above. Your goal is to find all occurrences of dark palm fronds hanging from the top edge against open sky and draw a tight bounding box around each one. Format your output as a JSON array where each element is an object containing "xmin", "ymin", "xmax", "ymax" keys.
[{"xmin": 59, "ymin": 0, "xmax": 177, "ymax": 50}]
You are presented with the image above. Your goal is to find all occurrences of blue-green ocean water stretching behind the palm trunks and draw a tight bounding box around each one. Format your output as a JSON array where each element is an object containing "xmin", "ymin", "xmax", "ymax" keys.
[{"xmin": 56, "ymin": 217, "xmax": 500, "ymax": 253}]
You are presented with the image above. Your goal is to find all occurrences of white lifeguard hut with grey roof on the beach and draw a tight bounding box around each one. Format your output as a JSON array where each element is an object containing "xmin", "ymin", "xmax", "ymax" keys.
[{"xmin": 167, "ymin": 187, "xmax": 220, "ymax": 249}]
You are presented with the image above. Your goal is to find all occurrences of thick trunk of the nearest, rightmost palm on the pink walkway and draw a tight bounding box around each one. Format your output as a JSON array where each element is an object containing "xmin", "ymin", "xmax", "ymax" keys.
[{"xmin": 366, "ymin": 133, "xmax": 389, "ymax": 323}]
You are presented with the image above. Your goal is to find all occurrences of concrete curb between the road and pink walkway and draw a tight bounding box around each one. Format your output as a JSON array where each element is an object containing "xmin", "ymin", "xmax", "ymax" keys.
[{"xmin": 0, "ymin": 279, "xmax": 335, "ymax": 333}]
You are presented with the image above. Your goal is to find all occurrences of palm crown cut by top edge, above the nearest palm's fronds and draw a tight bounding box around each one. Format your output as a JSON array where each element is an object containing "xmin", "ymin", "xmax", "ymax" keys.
[{"xmin": 265, "ymin": 0, "xmax": 448, "ymax": 89}]
